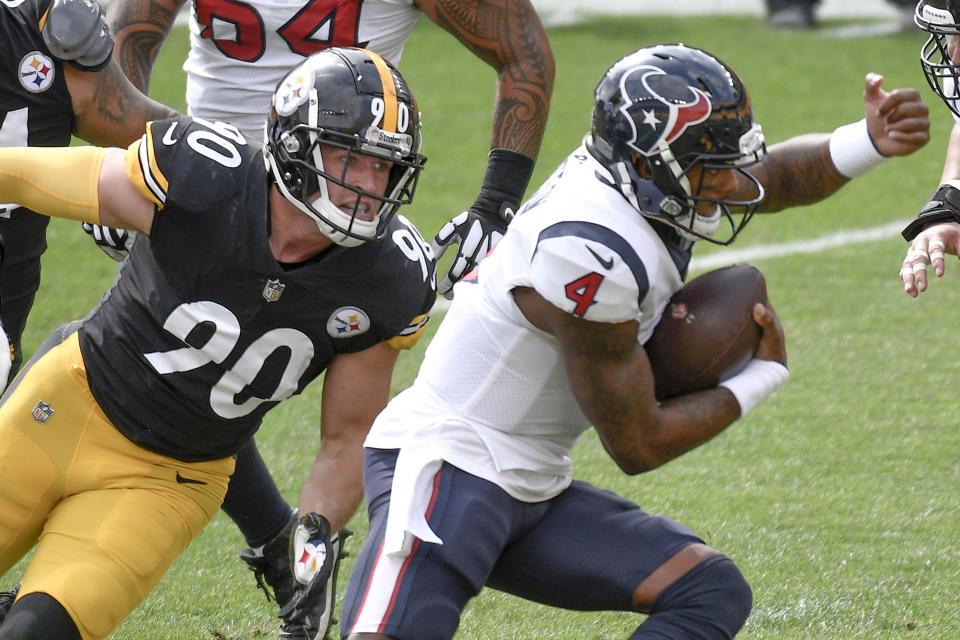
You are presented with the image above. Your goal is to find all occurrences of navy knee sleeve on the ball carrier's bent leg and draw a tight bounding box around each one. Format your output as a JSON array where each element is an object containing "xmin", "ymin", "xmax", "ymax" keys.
[{"xmin": 649, "ymin": 555, "xmax": 753, "ymax": 638}]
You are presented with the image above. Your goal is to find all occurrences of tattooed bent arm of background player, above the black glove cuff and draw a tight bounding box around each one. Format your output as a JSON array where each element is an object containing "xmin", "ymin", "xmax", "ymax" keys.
[{"xmin": 419, "ymin": 0, "xmax": 554, "ymax": 158}]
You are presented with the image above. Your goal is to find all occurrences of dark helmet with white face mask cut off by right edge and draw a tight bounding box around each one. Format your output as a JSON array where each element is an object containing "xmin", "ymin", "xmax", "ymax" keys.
[{"xmin": 913, "ymin": 0, "xmax": 960, "ymax": 118}]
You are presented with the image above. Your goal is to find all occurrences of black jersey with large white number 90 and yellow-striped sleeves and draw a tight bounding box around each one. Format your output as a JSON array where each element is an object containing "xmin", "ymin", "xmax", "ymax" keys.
[{"xmin": 80, "ymin": 117, "xmax": 435, "ymax": 461}]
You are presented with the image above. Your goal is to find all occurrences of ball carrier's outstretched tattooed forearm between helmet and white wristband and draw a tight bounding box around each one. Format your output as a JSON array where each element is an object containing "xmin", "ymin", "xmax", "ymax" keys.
[{"xmin": 750, "ymin": 133, "xmax": 849, "ymax": 212}]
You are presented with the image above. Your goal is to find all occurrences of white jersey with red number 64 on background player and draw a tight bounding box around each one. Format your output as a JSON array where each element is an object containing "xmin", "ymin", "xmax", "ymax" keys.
[{"xmin": 183, "ymin": 0, "xmax": 422, "ymax": 143}]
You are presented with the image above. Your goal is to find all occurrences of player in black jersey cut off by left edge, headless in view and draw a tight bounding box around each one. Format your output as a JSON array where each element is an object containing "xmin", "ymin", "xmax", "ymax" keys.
[{"xmin": 0, "ymin": 0, "xmax": 176, "ymax": 386}]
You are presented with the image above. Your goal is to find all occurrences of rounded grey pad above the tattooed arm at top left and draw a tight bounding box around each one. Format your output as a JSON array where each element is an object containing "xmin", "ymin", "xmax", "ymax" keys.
[{"xmin": 41, "ymin": 0, "xmax": 113, "ymax": 71}]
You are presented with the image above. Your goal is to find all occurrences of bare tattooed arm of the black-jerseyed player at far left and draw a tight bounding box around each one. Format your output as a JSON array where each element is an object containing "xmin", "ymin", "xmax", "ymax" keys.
[{"xmin": 64, "ymin": 60, "xmax": 178, "ymax": 147}]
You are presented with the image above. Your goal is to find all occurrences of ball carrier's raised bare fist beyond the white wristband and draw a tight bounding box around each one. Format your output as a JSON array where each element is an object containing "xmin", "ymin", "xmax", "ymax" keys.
[{"xmin": 863, "ymin": 73, "xmax": 930, "ymax": 157}]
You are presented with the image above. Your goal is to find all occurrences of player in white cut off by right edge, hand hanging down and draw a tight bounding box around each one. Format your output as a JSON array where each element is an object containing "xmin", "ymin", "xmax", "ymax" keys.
[{"xmin": 900, "ymin": 0, "xmax": 960, "ymax": 298}]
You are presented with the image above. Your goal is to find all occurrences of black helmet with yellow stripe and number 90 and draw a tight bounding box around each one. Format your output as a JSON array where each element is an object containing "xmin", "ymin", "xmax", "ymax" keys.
[{"xmin": 264, "ymin": 47, "xmax": 426, "ymax": 247}]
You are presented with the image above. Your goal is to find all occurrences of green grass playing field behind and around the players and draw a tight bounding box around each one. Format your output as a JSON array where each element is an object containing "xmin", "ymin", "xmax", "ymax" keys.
[{"xmin": 13, "ymin": 12, "xmax": 960, "ymax": 640}]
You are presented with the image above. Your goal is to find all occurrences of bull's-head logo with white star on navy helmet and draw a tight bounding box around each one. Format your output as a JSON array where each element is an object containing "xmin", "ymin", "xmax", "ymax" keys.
[{"xmin": 620, "ymin": 65, "xmax": 712, "ymax": 157}]
